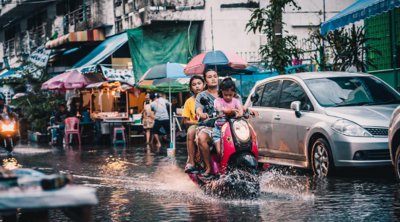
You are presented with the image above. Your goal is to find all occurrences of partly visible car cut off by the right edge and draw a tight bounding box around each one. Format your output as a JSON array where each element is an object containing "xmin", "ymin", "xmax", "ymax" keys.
[{"xmin": 389, "ymin": 106, "xmax": 400, "ymax": 181}]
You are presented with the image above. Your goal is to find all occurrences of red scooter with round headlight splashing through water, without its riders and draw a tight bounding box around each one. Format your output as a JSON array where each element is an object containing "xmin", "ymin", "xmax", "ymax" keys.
[{"xmin": 189, "ymin": 99, "xmax": 260, "ymax": 197}]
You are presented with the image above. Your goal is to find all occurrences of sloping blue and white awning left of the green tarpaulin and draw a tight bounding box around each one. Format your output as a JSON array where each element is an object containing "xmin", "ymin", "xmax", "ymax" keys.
[{"xmin": 73, "ymin": 32, "xmax": 128, "ymax": 68}]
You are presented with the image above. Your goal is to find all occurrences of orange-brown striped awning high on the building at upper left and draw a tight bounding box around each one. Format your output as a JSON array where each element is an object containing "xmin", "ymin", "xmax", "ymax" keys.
[{"xmin": 46, "ymin": 29, "xmax": 105, "ymax": 49}]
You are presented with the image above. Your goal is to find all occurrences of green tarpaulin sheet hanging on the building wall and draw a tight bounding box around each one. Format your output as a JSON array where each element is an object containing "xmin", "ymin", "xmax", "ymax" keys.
[{"xmin": 127, "ymin": 22, "xmax": 200, "ymax": 81}]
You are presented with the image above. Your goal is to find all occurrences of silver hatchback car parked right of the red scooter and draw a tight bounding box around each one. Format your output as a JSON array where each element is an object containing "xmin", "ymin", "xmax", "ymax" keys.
[{"xmin": 245, "ymin": 72, "xmax": 400, "ymax": 176}]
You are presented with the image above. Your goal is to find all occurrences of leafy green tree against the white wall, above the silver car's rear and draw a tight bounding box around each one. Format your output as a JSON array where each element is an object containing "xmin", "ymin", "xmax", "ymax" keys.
[{"xmin": 246, "ymin": 0, "xmax": 303, "ymax": 73}]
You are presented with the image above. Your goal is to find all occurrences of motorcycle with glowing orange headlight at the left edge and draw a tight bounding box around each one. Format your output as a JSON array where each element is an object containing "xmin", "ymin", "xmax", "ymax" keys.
[{"xmin": 0, "ymin": 113, "xmax": 19, "ymax": 152}]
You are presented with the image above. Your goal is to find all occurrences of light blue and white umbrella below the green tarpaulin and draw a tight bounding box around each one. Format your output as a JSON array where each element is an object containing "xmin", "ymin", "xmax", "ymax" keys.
[{"xmin": 140, "ymin": 62, "xmax": 185, "ymax": 81}]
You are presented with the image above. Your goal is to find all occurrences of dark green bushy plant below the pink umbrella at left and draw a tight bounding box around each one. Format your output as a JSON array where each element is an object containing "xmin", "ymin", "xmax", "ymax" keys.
[{"xmin": 11, "ymin": 91, "xmax": 65, "ymax": 132}]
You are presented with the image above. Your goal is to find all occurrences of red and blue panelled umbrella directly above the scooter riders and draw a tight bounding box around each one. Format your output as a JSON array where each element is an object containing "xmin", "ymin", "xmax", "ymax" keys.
[{"xmin": 184, "ymin": 50, "xmax": 247, "ymax": 75}]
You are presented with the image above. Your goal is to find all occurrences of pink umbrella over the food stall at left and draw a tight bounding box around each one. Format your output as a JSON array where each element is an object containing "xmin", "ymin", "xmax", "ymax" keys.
[{"xmin": 41, "ymin": 69, "xmax": 105, "ymax": 90}]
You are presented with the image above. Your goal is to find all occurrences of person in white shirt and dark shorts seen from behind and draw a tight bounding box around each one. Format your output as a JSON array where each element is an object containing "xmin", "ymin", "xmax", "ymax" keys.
[{"xmin": 151, "ymin": 93, "xmax": 171, "ymax": 152}]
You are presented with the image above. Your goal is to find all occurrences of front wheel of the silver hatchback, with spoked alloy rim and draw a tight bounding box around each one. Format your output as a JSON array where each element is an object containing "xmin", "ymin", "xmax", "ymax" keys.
[{"xmin": 311, "ymin": 138, "xmax": 334, "ymax": 177}]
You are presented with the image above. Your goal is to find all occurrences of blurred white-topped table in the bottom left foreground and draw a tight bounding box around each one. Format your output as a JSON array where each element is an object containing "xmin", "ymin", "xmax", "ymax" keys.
[{"xmin": 0, "ymin": 185, "xmax": 98, "ymax": 221}]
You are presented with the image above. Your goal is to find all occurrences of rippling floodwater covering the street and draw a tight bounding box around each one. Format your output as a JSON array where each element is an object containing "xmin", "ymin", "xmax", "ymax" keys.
[{"xmin": 0, "ymin": 145, "xmax": 400, "ymax": 221}]
